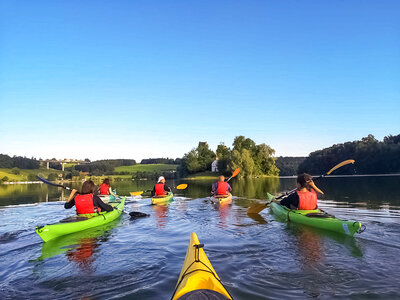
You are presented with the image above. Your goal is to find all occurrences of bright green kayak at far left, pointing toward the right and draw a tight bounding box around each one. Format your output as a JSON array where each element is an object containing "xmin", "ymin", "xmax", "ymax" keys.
[{"xmin": 35, "ymin": 197, "xmax": 126, "ymax": 242}]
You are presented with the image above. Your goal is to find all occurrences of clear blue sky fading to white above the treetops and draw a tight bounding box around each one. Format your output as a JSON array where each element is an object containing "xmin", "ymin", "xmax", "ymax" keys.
[{"xmin": 0, "ymin": 0, "xmax": 400, "ymax": 159}]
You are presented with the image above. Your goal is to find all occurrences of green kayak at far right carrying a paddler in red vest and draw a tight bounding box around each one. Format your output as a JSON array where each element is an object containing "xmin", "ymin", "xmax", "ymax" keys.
[{"xmin": 268, "ymin": 194, "xmax": 365, "ymax": 236}]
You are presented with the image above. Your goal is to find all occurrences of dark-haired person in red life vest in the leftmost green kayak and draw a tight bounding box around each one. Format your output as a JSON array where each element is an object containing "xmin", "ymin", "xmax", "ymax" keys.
[{"xmin": 64, "ymin": 180, "xmax": 114, "ymax": 215}]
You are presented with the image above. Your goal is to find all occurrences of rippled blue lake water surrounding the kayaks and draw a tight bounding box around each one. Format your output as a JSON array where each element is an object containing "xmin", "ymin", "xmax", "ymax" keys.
[{"xmin": 0, "ymin": 176, "xmax": 400, "ymax": 299}]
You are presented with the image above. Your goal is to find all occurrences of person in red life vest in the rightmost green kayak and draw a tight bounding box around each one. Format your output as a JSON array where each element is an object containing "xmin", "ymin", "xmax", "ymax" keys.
[{"xmin": 280, "ymin": 173, "xmax": 323, "ymax": 210}]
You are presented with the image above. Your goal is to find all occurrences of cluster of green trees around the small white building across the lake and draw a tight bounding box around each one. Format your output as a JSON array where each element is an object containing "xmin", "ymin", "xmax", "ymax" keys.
[{"xmin": 178, "ymin": 136, "xmax": 279, "ymax": 177}]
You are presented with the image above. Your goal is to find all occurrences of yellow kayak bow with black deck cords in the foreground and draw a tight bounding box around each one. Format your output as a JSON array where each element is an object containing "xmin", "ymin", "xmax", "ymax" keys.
[{"xmin": 172, "ymin": 232, "xmax": 232, "ymax": 300}]
